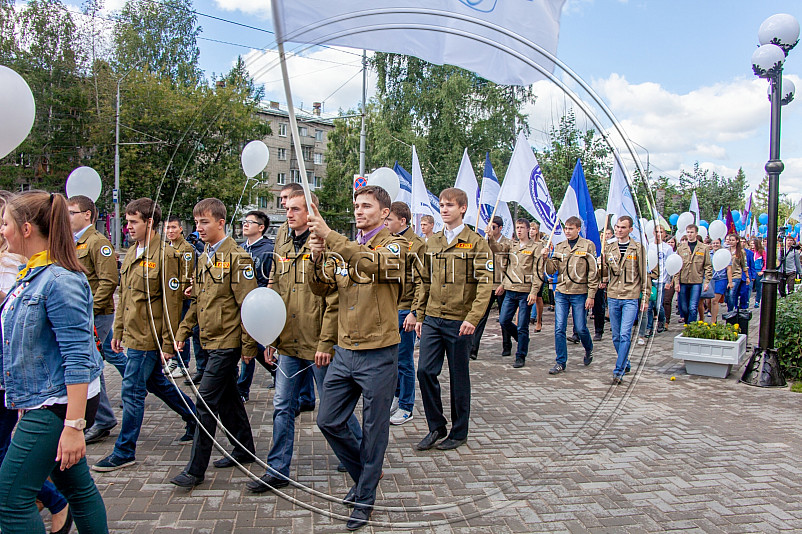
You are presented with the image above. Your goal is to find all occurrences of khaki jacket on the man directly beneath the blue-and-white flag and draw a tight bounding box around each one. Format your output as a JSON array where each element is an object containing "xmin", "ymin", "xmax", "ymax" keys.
[{"xmin": 541, "ymin": 236, "xmax": 600, "ymax": 299}]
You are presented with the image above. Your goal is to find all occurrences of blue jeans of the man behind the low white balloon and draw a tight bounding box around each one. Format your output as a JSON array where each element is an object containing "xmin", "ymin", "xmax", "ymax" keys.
[{"xmin": 267, "ymin": 354, "xmax": 362, "ymax": 477}]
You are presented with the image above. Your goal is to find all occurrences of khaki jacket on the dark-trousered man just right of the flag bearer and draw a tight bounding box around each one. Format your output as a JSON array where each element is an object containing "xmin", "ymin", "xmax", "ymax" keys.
[{"xmin": 413, "ymin": 225, "xmax": 494, "ymax": 326}]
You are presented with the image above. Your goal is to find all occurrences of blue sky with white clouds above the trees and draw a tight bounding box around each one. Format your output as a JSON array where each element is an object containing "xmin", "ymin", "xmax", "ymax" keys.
[{"xmin": 67, "ymin": 0, "xmax": 802, "ymax": 207}]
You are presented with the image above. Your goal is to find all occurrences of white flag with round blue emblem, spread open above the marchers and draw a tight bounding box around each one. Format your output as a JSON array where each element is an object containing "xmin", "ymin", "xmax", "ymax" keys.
[{"xmin": 498, "ymin": 133, "xmax": 565, "ymax": 244}]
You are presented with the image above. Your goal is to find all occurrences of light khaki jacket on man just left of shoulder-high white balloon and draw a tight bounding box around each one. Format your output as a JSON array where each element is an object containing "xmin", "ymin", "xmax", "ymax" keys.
[{"xmin": 601, "ymin": 242, "xmax": 652, "ymax": 300}]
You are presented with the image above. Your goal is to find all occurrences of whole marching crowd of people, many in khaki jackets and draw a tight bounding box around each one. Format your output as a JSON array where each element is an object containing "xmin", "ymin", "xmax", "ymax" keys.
[{"xmin": 0, "ymin": 184, "xmax": 802, "ymax": 533}]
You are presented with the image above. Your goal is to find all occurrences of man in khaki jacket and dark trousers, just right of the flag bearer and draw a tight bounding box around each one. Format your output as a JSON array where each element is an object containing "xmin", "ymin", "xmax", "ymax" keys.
[{"xmin": 413, "ymin": 187, "xmax": 493, "ymax": 451}]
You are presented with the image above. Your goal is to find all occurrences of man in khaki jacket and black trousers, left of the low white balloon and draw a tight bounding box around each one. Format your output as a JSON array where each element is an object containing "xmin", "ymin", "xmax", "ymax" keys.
[{"xmin": 170, "ymin": 198, "xmax": 257, "ymax": 488}]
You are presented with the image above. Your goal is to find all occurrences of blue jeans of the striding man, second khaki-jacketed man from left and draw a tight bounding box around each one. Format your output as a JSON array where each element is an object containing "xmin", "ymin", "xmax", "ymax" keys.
[{"xmin": 113, "ymin": 349, "xmax": 196, "ymax": 460}]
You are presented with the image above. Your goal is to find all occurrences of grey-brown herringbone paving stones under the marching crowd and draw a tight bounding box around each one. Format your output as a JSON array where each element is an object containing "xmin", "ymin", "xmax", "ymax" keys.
[{"xmin": 83, "ymin": 311, "xmax": 802, "ymax": 534}]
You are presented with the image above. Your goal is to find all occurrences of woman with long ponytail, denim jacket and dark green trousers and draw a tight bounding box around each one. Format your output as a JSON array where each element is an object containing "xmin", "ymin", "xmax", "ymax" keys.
[{"xmin": 0, "ymin": 191, "xmax": 108, "ymax": 534}]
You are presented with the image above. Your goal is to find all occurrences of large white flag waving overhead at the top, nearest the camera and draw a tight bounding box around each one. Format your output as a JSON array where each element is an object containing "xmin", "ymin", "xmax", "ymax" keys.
[{"xmin": 273, "ymin": 0, "xmax": 565, "ymax": 85}]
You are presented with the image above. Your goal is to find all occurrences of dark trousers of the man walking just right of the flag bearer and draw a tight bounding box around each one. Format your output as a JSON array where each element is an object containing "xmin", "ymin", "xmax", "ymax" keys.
[{"xmin": 418, "ymin": 316, "xmax": 472, "ymax": 440}]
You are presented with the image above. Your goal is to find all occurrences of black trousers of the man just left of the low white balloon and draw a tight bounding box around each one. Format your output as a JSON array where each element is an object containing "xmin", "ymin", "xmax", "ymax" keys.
[{"xmin": 186, "ymin": 348, "xmax": 255, "ymax": 477}]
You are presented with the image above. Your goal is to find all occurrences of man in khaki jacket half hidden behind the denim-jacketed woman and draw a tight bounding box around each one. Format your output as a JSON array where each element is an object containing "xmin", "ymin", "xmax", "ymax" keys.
[{"xmin": 67, "ymin": 195, "xmax": 120, "ymax": 445}]
